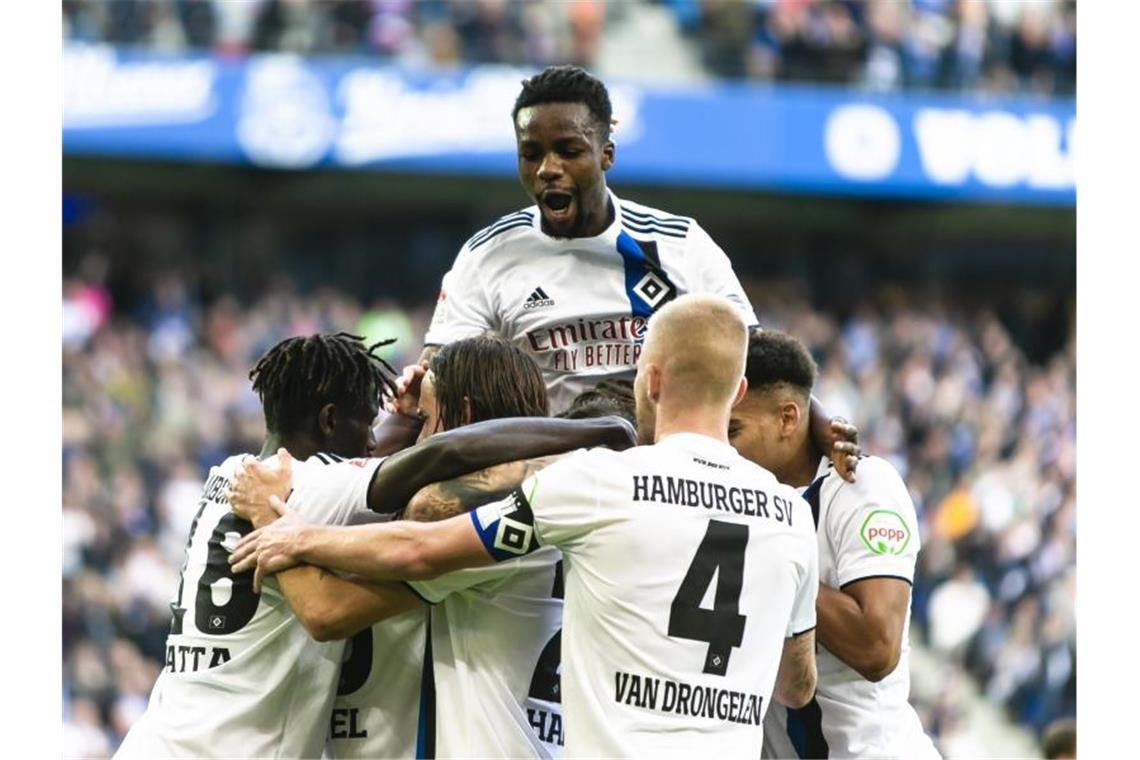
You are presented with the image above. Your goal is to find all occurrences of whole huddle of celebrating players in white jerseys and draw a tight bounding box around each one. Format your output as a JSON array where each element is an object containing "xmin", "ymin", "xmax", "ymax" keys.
[{"xmin": 116, "ymin": 67, "xmax": 937, "ymax": 758}]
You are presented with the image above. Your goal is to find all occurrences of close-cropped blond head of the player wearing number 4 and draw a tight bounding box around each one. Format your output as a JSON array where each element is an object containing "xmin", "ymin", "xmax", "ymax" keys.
[{"xmin": 635, "ymin": 295, "xmax": 748, "ymax": 442}]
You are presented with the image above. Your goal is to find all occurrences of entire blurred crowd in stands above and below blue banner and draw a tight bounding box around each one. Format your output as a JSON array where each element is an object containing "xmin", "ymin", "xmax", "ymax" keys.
[{"xmin": 63, "ymin": 0, "xmax": 1076, "ymax": 757}]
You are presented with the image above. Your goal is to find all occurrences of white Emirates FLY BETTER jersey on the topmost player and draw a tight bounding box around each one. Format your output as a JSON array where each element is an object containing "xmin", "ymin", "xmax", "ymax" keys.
[{"xmin": 424, "ymin": 191, "xmax": 756, "ymax": 414}]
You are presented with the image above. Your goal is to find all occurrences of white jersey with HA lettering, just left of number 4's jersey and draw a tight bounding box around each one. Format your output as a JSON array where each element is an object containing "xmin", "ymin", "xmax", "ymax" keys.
[{"xmin": 408, "ymin": 547, "xmax": 565, "ymax": 759}]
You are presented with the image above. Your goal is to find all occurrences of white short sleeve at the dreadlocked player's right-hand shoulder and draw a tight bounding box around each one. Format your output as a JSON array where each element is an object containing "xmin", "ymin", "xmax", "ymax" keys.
[{"xmin": 288, "ymin": 455, "xmax": 384, "ymax": 525}]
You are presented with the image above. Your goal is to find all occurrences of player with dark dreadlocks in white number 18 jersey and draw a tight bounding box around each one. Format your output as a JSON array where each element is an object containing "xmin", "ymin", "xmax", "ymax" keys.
[{"xmin": 116, "ymin": 333, "xmax": 628, "ymax": 758}]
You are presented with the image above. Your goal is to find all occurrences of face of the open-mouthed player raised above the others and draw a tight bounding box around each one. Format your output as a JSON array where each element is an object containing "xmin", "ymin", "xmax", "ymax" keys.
[{"xmin": 514, "ymin": 103, "xmax": 613, "ymax": 237}]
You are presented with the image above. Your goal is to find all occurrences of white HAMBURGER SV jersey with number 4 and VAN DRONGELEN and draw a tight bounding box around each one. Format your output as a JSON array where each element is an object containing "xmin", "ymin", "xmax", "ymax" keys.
[{"xmin": 471, "ymin": 433, "xmax": 819, "ymax": 758}]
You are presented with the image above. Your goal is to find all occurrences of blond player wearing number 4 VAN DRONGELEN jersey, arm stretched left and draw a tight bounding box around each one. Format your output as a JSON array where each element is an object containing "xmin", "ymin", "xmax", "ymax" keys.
[{"xmin": 231, "ymin": 295, "xmax": 819, "ymax": 757}]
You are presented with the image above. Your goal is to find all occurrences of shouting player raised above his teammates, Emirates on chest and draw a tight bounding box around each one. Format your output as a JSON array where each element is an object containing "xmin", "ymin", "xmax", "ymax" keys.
[{"xmin": 400, "ymin": 66, "xmax": 857, "ymax": 487}]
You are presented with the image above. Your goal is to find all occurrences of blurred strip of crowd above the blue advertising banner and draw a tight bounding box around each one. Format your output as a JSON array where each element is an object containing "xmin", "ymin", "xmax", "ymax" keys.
[{"xmin": 63, "ymin": 0, "xmax": 1076, "ymax": 95}]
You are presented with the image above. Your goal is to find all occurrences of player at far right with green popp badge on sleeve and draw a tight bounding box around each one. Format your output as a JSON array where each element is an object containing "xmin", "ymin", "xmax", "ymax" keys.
[{"xmin": 728, "ymin": 330, "xmax": 938, "ymax": 759}]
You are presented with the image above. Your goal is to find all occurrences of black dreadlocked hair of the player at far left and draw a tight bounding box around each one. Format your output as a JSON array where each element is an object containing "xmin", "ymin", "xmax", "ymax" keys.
[{"xmin": 250, "ymin": 333, "xmax": 396, "ymax": 433}]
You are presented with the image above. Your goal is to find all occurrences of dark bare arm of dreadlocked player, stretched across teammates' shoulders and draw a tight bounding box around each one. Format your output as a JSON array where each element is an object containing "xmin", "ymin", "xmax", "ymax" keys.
[{"xmin": 368, "ymin": 417, "xmax": 637, "ymax": 514}]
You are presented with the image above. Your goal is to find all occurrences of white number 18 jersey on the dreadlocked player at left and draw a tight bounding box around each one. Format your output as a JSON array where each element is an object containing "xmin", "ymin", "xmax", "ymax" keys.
[{"xmin": 115, "ymin": 455, "xmax": 381, "ymax": 758}]
